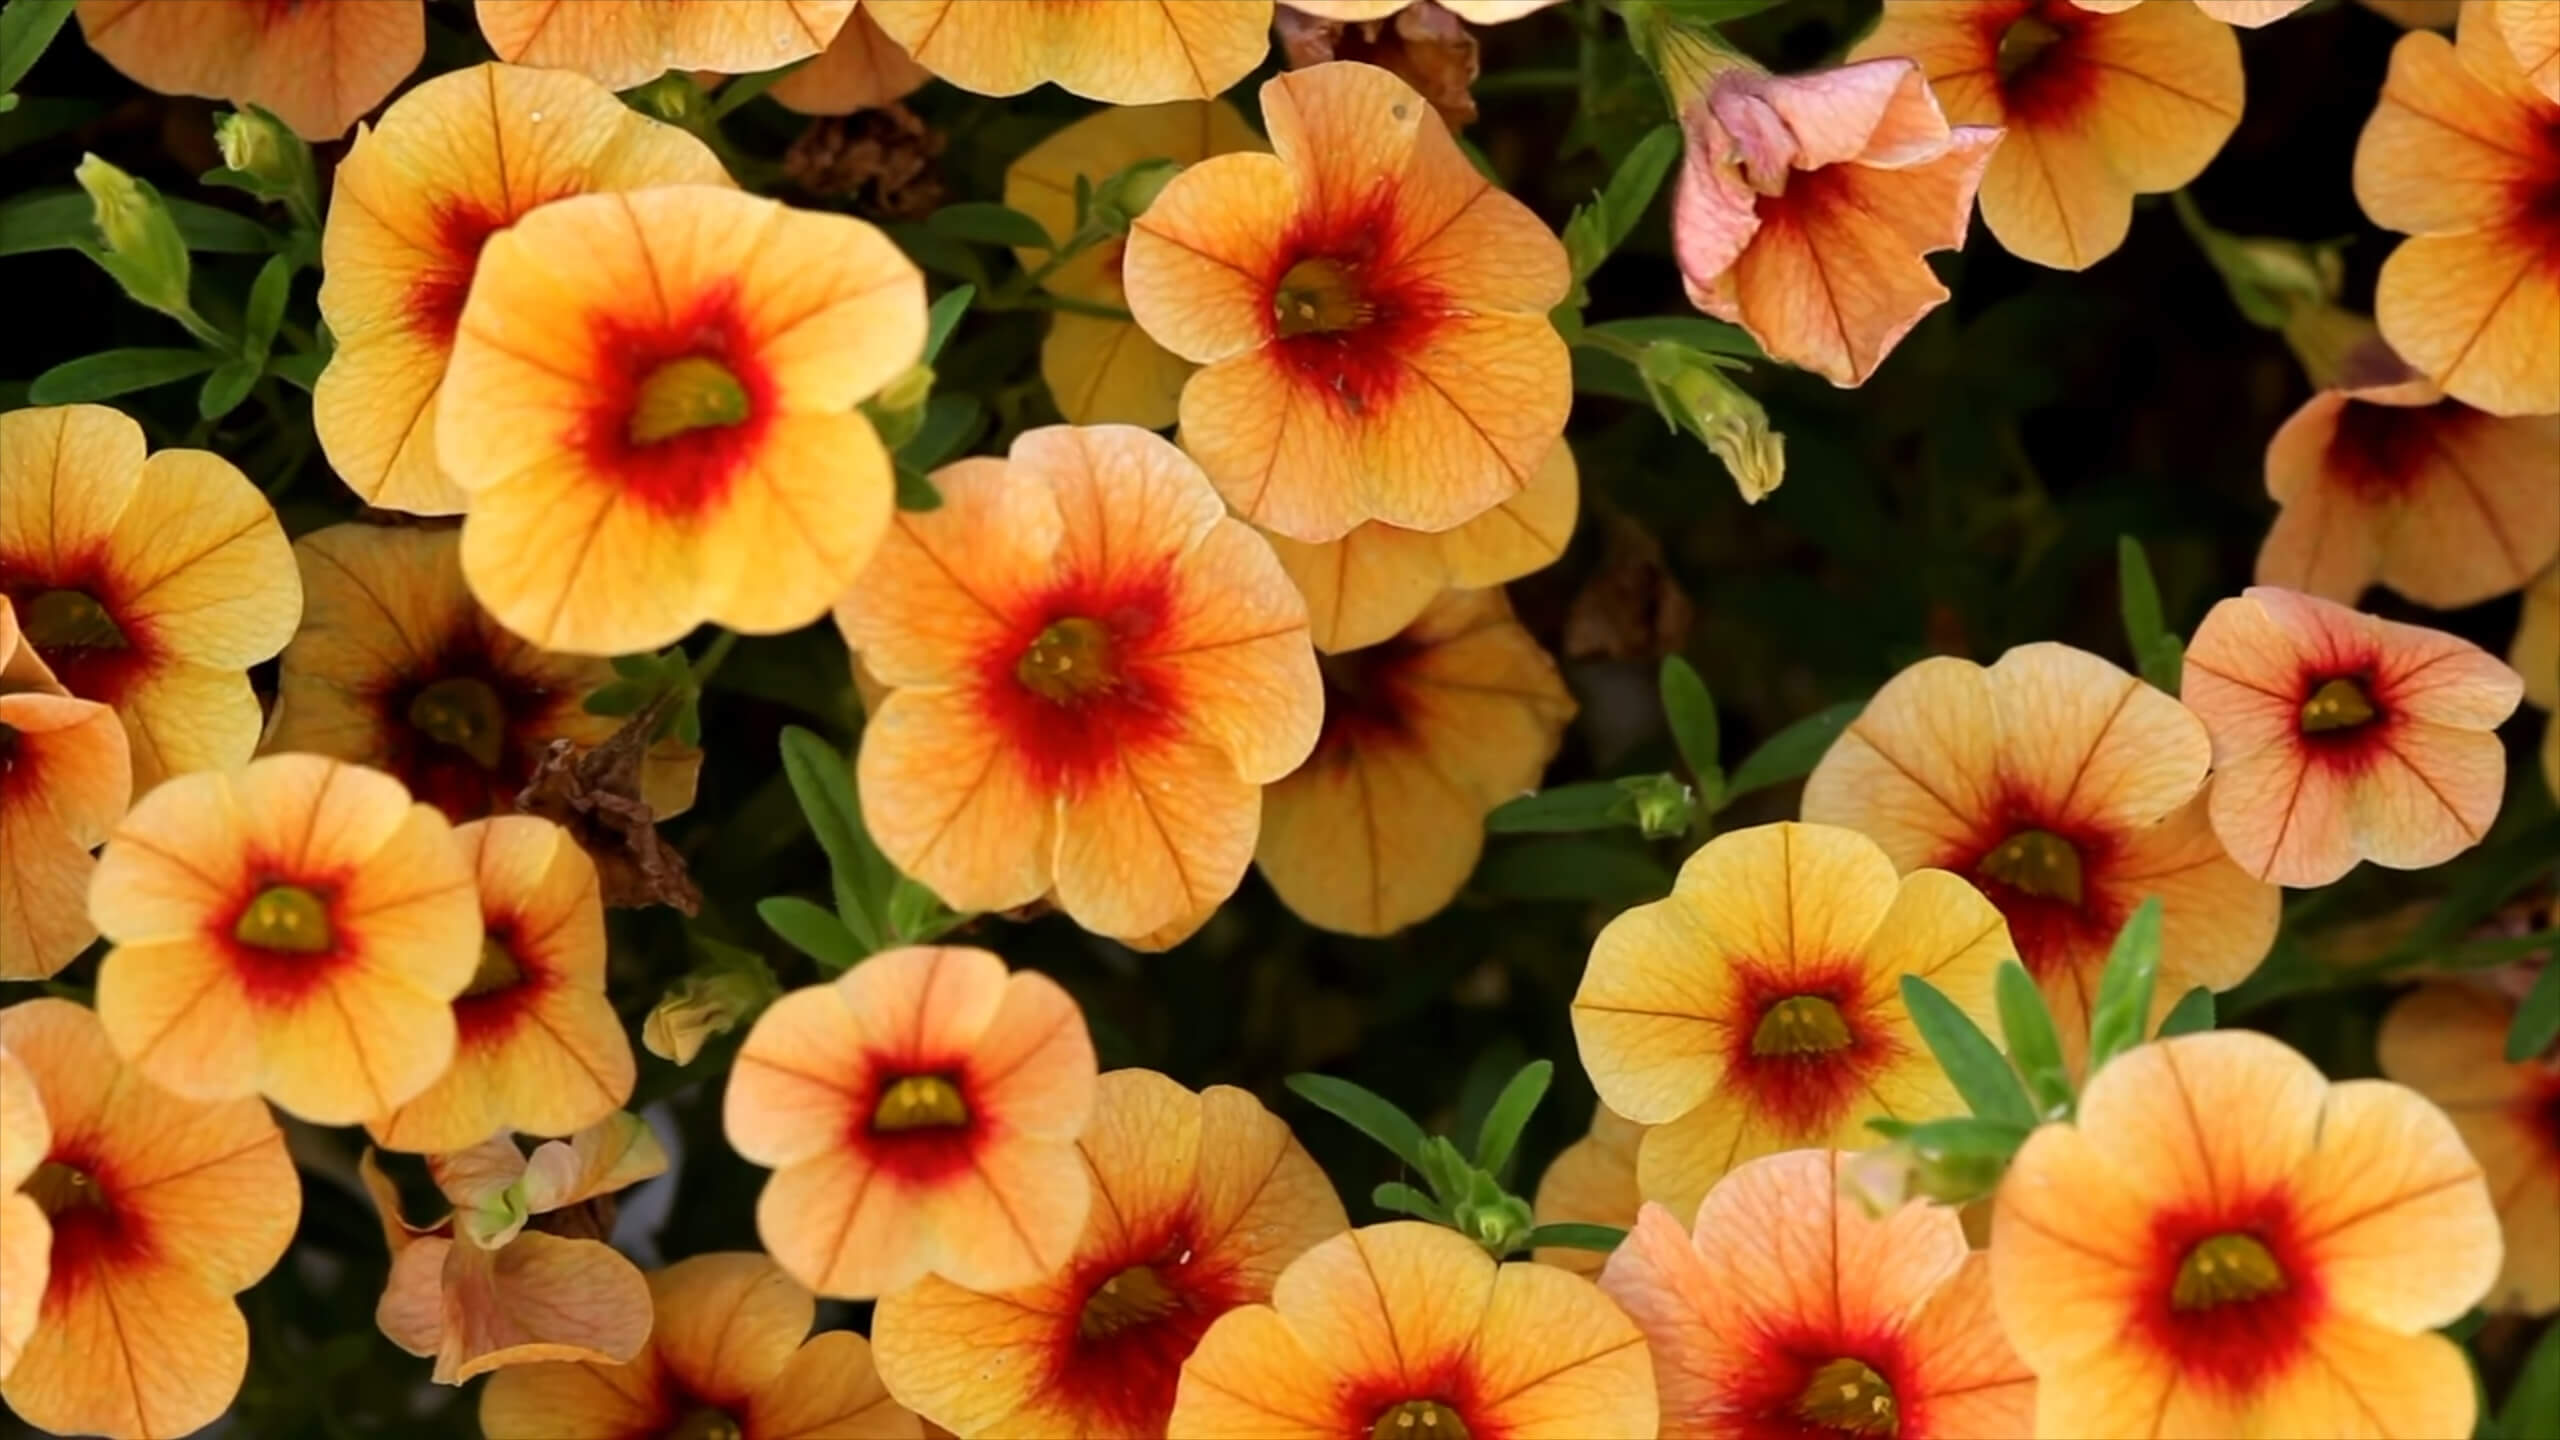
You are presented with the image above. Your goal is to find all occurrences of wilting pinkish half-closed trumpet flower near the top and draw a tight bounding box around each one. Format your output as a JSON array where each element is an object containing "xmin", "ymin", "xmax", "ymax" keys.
[{"xmin": 1672, "ymin": 59, "xmax": 1999, "ymax": 384}]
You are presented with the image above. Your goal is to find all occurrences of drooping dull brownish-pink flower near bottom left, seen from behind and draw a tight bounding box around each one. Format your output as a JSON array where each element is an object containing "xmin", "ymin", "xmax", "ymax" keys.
[{"xmin": 373, "ymin": 1115, "xmax": 666, "ymax": 1386}]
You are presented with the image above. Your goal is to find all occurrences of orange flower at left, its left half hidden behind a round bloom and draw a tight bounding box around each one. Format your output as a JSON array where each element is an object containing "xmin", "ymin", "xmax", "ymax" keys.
[{"xmin": 366, "ymin": 815, "xmax": 635, "ymax": 1150}]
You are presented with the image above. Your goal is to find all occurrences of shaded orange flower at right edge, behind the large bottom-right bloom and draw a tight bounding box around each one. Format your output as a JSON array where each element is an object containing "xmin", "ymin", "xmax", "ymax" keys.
[{"xmin": 2381, "ymin": 984, "xmax": 2560, "ymax": 1314}]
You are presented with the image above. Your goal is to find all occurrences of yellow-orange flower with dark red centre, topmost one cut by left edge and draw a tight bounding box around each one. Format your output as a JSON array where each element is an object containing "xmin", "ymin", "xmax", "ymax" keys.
[{"xmin": 0, "ymin": 405, "xmax": 302, "ymax": 794}]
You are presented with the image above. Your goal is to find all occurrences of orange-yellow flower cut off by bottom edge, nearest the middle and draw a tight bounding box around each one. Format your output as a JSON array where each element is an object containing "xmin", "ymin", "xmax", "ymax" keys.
[{"xmin": 1165, "ymin": 1220, "xmax": 1656, "ymax": 1440}]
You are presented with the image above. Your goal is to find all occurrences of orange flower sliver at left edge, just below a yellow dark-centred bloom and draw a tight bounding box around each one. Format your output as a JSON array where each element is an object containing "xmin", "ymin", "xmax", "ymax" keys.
[{"xmin": 0, "ymin": 594, "xmax": 133, "ymax": 973}]
